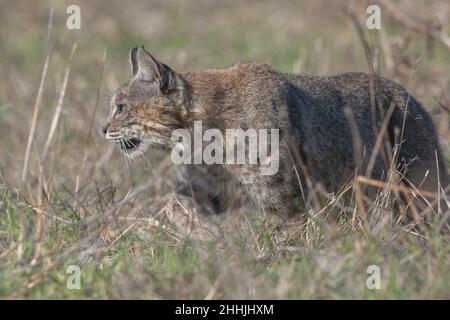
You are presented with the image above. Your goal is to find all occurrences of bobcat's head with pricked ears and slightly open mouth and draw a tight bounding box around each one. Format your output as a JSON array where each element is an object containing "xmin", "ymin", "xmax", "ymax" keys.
[{"xmin": 102, "ymin": 48, "xmax": 187, "ymax": 159}]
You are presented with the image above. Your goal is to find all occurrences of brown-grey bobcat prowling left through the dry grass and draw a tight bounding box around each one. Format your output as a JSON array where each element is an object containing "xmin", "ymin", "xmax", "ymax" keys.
[{"xmin": 102, "ymin": 48, "xmax": 449, "ymax": 219}]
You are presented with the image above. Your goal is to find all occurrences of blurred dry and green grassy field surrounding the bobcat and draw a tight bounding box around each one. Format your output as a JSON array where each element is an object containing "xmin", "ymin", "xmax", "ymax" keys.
[{"xmin": 0, "ymin": 0, "xmax": 450, "ymax": 299}]
